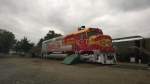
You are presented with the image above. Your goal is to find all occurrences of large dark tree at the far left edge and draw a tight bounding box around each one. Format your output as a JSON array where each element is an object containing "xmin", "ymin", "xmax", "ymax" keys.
[{"xmin": 0, "ymin": 29, "xmax": 15, "ymax": 53}]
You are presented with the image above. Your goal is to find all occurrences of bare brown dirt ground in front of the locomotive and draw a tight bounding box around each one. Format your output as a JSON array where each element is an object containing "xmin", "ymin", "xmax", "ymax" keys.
[{"xmin": 0, "ymin": 57, "xmax": 150, "ymax": 84}]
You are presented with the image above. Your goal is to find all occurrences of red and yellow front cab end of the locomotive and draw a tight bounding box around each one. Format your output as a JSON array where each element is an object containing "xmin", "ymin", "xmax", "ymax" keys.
[{"xmin": 76, "ymin": 28, "xmax": 116, "ymax": 64}]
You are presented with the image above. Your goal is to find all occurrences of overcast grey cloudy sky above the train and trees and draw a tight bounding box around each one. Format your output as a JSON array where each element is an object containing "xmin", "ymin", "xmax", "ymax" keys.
[{"xmin": 0, "ymin": 0, "xmax": 150, "ymax": 42}]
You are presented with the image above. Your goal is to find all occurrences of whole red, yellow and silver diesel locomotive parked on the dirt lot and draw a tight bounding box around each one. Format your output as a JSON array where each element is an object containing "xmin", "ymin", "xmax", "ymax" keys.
[{"xmin": 41, "ymin": 26, "xmax": 117, "ymax": 64}]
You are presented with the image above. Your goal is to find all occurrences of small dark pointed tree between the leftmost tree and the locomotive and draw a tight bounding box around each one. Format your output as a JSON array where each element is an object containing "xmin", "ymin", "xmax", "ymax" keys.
[{"xmin": 15, "ymin": 37, "xmax": 34, "ymax": 53}]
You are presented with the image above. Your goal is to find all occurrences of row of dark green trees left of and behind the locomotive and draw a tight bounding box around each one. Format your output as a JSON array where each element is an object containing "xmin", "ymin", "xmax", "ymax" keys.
[{"xmin": 0, "ymin": 29, "xmax": 61, "ymax": 56}]
